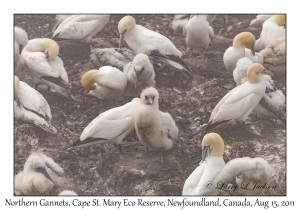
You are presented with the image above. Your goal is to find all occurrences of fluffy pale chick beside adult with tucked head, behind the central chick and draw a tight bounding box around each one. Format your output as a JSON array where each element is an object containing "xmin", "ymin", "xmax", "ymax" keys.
[{"xmin": 123, "ymin": 53, "xmax": 156, "ymax": 97}]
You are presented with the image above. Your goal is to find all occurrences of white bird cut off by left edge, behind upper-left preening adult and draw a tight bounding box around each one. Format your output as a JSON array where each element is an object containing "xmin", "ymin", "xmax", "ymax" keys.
[{"xmin": 14, "ymin": 26, "xmax": 28, "ymax": 80}]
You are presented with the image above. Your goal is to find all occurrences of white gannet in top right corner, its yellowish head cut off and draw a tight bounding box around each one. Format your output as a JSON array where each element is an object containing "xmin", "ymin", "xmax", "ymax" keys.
[{"xmin": 254, "ymin": 15, "xmax": 286, "ymax": 52}]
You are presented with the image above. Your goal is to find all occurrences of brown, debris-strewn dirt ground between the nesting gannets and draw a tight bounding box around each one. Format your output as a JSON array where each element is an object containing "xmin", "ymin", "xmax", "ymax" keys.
[{"xmin": 14, "ymin": 14, "xmax": 286, "ymax": 195}]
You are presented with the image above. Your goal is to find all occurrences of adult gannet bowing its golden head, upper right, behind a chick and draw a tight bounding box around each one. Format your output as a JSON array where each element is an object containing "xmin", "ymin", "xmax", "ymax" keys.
[{"xmin": 223, "ymin": 32, "xmax": 263, "ymax": 75}]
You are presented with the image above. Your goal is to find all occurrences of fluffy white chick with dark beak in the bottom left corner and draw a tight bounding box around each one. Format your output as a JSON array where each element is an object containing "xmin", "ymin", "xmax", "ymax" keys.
[{"xmin": 15, "ymin": 152, "xmax": 63, "ymax": 195}]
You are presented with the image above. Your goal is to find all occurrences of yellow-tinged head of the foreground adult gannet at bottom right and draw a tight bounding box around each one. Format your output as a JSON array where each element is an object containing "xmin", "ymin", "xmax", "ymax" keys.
[{"xmin": 202, "ymin": 133, "xmax": 224, "ymax": 161}]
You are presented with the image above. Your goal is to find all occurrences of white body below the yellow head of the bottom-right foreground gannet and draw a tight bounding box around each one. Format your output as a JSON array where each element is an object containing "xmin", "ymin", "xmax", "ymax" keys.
[{"xmin": 182, "ymin": 156, "xmax": 225, "ymax": 195}]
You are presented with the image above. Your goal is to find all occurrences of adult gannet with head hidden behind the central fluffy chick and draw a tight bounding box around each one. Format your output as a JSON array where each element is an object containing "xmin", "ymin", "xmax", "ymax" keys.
[{"xmin": 68, "ymin": 98, "xmax": 140, "ymax": 152}]
